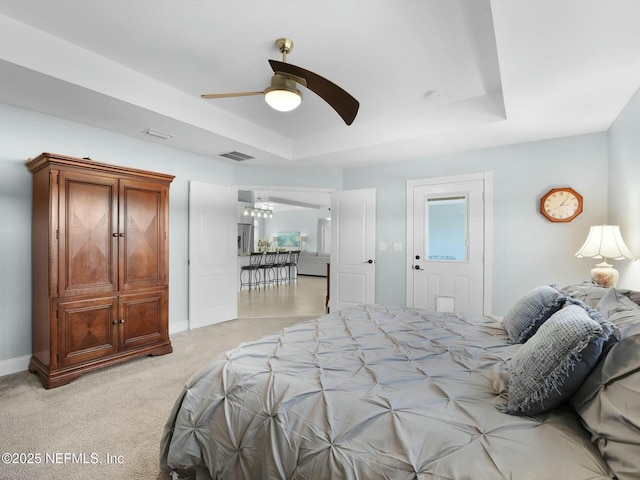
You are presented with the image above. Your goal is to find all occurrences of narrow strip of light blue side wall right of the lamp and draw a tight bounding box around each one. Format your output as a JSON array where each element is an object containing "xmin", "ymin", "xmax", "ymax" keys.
[{"xmin": 609, "ymin": 86, "xmax": 640, "ymax": 290}]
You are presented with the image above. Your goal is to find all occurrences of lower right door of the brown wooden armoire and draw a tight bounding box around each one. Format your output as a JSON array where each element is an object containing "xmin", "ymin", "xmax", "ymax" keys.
[{"xmin": 119, "ymin": 290, "xmax": 168, "ymax": 350}]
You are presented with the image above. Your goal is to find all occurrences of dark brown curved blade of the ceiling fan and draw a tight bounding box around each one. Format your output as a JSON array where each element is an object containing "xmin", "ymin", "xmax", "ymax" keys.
[{"xmin": 269, "ymin": 60, "xmax": 360, "ymax": 125}]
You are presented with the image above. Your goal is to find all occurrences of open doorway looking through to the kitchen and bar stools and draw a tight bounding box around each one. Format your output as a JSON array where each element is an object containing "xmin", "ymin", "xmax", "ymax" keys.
[{"xmin": 237, "ymin": 186, "xmax": 333, "ymax": 318}]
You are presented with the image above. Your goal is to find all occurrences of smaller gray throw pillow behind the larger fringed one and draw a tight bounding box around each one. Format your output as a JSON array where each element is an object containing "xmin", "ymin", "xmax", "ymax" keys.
[{"xmin": 502, "ymin": 285, "xmax": 567, "ymax": 343}]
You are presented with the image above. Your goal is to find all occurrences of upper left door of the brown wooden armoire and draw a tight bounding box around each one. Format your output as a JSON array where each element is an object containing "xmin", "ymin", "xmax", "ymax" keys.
[{"xmin": 58, "ymin": 171, "xmax": 118, "ymax": 297}]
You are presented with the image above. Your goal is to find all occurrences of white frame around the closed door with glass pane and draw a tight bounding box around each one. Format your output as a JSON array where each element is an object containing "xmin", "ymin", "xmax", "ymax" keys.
[{"xmin": 405, "ymin": 172, "xmax": 493, "ymax": 315}]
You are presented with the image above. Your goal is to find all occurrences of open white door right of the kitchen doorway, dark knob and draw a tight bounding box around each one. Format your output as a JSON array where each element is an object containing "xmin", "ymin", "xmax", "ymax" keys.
[{"xmin": 329, "ymin": 189, "xmax": 376, "ymax": 312}]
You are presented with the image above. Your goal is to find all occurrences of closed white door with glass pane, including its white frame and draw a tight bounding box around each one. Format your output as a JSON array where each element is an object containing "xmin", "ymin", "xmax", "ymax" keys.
[{"xmin": 407, "ymin": 177, "xmax": 486, "ymax": 315}]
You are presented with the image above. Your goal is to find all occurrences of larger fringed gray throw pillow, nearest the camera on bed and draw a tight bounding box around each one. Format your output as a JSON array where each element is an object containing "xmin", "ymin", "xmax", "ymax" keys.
[{"xmin": 498, "ymin": 304, "xmax": 614, "ymax": 415}]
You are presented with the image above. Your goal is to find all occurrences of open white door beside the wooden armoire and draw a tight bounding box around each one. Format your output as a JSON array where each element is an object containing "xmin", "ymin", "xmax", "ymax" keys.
[{"xmin": 189, "ymin": 181, "xmax": 238, "ymax": 329}]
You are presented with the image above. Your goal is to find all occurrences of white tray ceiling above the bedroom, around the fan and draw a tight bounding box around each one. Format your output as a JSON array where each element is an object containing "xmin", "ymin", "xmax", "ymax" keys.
[{"xmin": 0, "ymin": 0, "xmax": 640, "ymax": 168}]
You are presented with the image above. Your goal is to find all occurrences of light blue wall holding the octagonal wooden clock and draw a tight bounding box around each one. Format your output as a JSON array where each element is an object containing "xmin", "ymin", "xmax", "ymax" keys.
[{"xmin": 344, "ymin": 133, "xmax": 607, "ymax": 315}]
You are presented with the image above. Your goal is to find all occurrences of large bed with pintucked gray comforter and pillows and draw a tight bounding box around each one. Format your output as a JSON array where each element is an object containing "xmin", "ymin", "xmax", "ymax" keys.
[{"xmin": 160, "ymin": 285, "xmax": 640, "ymax": 480}]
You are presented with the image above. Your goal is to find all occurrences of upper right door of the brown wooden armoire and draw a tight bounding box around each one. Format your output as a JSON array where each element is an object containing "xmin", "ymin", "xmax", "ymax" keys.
[{"xmin": 120, "ymin": 180, "xmax": 167, "ymax": 290}]
